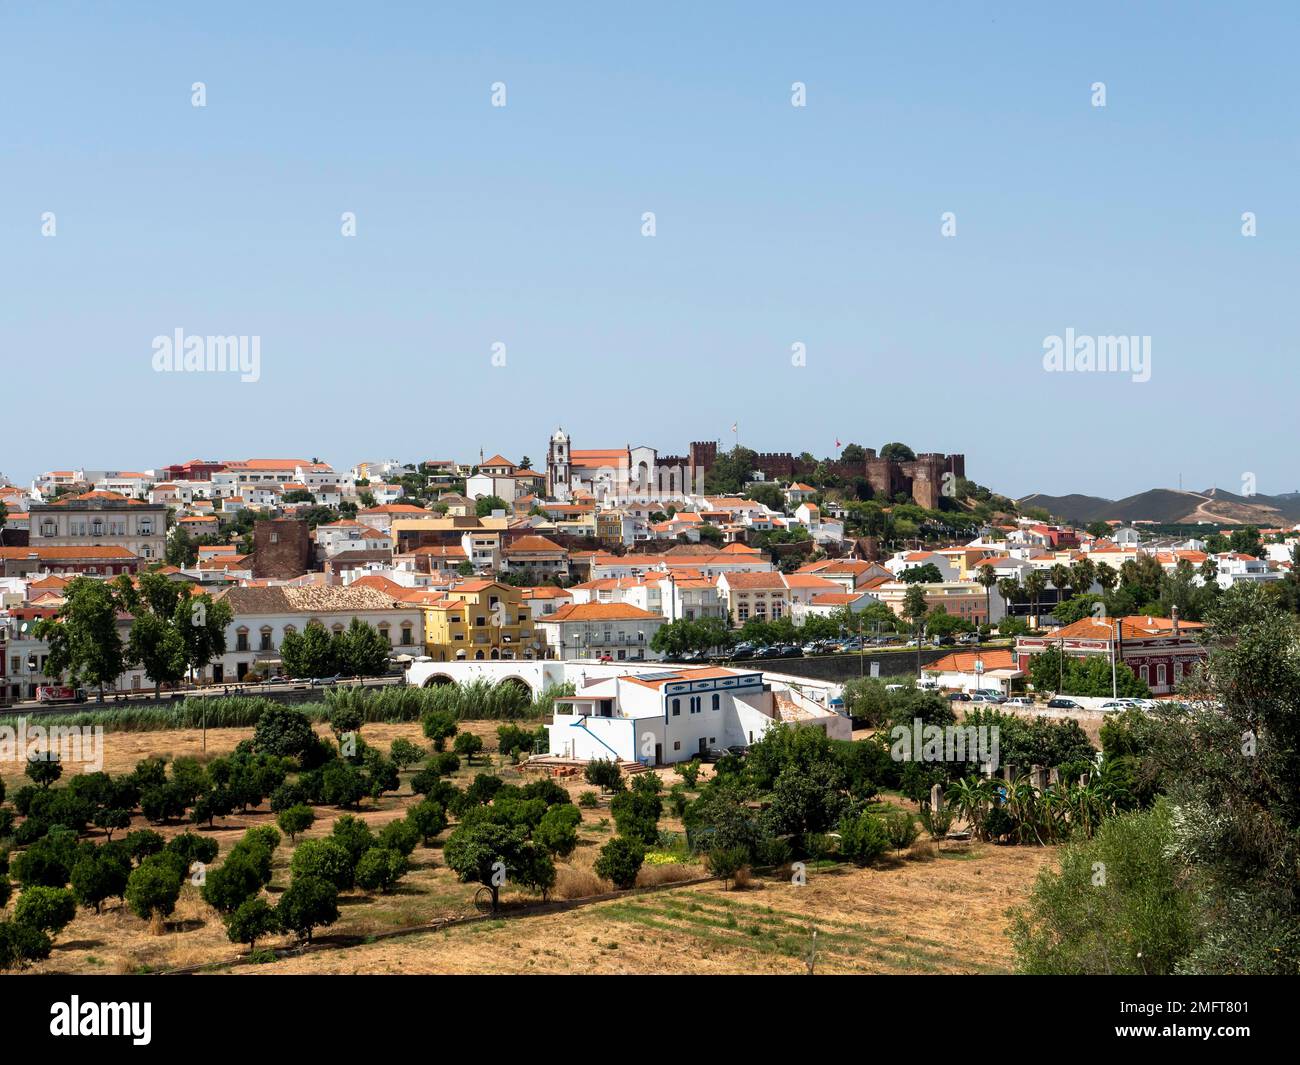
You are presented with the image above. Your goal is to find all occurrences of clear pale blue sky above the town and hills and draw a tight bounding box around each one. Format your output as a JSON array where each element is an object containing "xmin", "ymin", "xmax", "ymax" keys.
[{"xmin": 0, "ymin": 3, "xmax": 1300, "ymax": 497}]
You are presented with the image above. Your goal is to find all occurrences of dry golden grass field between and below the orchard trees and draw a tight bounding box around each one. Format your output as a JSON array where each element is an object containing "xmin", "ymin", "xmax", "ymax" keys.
[{"xmin": 5, "ymin": 722, "xmax": 1052, "ymax": 974}]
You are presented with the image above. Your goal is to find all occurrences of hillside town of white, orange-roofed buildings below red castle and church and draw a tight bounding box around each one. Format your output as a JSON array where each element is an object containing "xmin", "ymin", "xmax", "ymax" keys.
[{"xmin": 0, "ymin": 428, "xmax": 1300, "ymax": 702}]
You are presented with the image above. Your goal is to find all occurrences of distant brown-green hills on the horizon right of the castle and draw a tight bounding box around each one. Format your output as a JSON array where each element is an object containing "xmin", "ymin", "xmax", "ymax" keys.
[{"xmin": 1017, "ymin": 488, "xmax": 1300, "ymax": 527}]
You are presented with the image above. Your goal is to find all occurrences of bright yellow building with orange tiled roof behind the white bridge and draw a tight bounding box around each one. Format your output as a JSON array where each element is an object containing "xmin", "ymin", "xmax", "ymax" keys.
[{"xmin": 424, "ymin": 580, "xmax": 546, "ymax": 662}]
